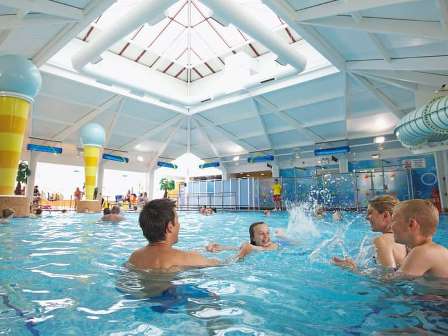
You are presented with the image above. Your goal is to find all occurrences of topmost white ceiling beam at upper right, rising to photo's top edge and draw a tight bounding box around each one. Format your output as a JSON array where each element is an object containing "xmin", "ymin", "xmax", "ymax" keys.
[{"xmin": 296, "ymin": 0, "xmax": 422, "ymax": 21}]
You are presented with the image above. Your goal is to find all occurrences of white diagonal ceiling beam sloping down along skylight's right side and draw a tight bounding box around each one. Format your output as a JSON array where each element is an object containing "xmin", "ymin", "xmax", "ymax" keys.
[{"xmin": 263, "ymin": 0, "xmax": 345, "ymax": 70}]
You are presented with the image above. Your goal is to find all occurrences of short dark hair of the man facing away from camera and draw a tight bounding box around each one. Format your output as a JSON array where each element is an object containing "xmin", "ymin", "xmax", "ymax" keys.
[{"xmin": 138, "ymin": 198, "xmax": 176, "ymax": 243}]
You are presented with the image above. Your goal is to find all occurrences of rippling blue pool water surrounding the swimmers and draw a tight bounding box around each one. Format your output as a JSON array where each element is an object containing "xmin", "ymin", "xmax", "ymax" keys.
[{"xmin": 0, "ymin": 212, "xmax": 448, "ymax": 336}]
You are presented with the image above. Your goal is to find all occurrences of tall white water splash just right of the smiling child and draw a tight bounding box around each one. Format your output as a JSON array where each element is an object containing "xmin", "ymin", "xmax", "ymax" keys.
[{"xmin": 286, "ymin": 203, "xmax": 320, "ymax": 240}]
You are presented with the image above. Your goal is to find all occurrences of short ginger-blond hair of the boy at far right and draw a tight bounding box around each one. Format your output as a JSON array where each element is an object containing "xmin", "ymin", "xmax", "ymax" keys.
[{"xmin": 394, "ymin": 199, "xmax": 439, "ymax": 237}]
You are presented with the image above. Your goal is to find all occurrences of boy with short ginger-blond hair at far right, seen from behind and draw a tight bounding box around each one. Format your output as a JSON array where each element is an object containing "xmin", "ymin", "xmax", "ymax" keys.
[{"xmin": 392, "ymin": 199, "xmax": 448, "ymax": 278}]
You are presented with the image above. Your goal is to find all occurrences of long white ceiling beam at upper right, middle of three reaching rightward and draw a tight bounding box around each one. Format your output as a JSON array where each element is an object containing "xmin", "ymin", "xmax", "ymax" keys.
[{"xmin": 303, "ymin": 16, "xmax": 448, "ymax": 40}]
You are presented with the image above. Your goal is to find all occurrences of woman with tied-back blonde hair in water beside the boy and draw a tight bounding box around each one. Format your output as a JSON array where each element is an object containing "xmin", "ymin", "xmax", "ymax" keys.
[{"xmin": 333, "ymin": 195, "xmax": 406, "ymax": 269}]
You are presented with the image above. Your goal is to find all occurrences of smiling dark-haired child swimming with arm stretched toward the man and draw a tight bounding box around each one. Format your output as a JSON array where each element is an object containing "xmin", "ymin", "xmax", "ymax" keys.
[{"xmin": 206, "ymin": 222, "xmax": 278, "ymax": 257}]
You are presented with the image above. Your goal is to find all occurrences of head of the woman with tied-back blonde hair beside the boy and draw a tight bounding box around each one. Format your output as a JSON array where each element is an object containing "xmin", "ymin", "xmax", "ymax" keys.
[{"xmin": 366, "ymin": 195, "xmax": 400, "ymax": 232}]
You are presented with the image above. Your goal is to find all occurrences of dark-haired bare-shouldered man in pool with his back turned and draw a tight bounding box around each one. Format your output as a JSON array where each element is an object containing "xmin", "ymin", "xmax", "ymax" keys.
[{"xmin": 129, "ymin": 198, "xmax": 234, "ymax": 270}]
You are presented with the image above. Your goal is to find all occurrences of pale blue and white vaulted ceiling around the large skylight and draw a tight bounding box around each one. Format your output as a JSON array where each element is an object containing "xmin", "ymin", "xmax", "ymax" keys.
[{"xmin": 0, "ymin": 0, "xmax": 448, "ymax": 166}]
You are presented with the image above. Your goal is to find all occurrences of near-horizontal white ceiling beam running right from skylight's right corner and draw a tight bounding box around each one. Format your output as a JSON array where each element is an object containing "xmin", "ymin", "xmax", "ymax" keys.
[{"xmin": 347, "ymin": 56, "xmax": 448, "ymax": 72}]
